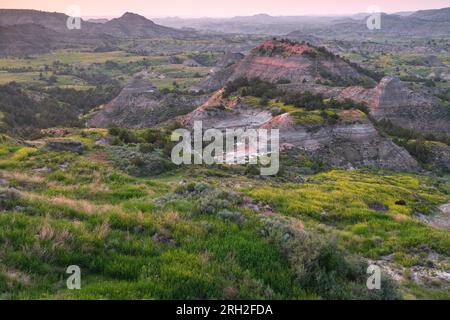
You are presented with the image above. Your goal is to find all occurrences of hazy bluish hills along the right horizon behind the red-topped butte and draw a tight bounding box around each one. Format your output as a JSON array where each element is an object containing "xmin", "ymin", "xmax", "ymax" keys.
[{"xmin": 156, "ymin": 8, "xmax": 450, "ymax": 38}]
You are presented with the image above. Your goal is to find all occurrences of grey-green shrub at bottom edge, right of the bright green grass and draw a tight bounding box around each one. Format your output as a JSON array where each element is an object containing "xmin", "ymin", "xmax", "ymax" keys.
[{"xmin": 262, "ymin": 217, "xmax": 400, "ymax": 300}]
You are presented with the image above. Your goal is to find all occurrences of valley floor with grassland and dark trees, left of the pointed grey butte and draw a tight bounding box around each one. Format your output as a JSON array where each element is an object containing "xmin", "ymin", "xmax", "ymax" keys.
[{"xmin": 0, "ymin": 50, "xmax": 214, "ymax": 137}]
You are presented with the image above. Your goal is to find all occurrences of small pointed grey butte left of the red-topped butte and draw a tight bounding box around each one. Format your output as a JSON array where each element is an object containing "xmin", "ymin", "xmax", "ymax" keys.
[{"xmin": 87, "ymin": 78, "xmax": 207, "ymax": 128}]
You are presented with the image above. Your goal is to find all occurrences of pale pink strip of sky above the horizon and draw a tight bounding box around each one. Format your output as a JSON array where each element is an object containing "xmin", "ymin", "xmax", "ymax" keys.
[{"xmin": 0, "ymin": 0, "xmax": 450, "ymax": 17}]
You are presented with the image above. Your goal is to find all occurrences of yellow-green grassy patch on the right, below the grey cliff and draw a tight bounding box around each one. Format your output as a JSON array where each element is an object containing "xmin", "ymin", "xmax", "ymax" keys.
[{"xmin": 246, "ymin": 171, "xmax": 450, "ymax": 258}]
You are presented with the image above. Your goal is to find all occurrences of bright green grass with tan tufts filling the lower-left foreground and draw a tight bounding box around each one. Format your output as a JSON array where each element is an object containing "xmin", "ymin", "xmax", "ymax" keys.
[{"xmin": 0, "ymin": 132, "xmax": 309, "ymax": 299}]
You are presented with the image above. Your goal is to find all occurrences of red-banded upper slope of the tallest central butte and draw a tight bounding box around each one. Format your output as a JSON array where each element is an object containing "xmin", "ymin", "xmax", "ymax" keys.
[{"xmin": 193, "ymin": 40, "xmax": 375, "ymax": 91}]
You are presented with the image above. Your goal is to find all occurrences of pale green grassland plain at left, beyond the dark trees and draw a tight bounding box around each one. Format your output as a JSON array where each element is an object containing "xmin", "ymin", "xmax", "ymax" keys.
[{"xmin": 0, "ymin": 49, "xmax": 214, "ymax": 90}]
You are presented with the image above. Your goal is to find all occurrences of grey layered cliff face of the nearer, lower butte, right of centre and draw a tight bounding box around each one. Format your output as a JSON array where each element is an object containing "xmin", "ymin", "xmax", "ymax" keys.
[{"xmin": 264, "ymin": 114, "xmax": 419, "ymax": 171}]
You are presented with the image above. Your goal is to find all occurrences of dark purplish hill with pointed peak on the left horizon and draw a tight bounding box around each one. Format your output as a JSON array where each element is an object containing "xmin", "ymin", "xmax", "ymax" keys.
[{"xmin": 0, "ymin": 9, "xmax": 195, "ymax": 56}]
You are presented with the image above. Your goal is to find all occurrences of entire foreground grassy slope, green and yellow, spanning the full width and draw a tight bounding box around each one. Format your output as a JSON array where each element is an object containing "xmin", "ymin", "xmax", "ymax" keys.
[{"xmin": 0, "ymin": 129, "xmax": 450, "ymax": 299}]
